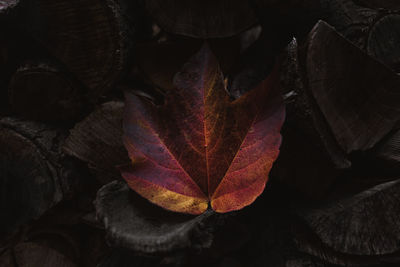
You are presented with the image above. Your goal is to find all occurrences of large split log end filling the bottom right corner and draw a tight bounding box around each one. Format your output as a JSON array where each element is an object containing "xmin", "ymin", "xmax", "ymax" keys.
[{"xmin": 297, "ymin": 180, "xmax": 400, "ymax": 265}]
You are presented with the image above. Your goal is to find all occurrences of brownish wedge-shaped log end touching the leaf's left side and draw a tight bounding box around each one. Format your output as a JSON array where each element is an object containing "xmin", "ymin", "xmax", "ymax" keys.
[{"xmin": 63, "ymin": 102, "xmax": 129, "ymax": 184}]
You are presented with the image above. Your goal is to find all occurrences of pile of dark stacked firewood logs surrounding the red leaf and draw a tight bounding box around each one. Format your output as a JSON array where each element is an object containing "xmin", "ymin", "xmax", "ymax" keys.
[{"xmin": 0, "ymin": 0, "xmax": 400, "ymax": 267}]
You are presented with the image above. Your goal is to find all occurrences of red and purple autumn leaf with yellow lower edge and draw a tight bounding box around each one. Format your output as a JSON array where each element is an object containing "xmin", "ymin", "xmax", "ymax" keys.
[{"xmin": 121, "ymin": 45, "xmax": 285, "ymax": 214}]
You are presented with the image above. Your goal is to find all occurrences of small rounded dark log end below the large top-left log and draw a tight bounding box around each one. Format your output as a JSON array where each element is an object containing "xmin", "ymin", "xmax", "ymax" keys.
[{"xmin": 9, "ymin": 63, "xmax": 85, "ymax": 121}]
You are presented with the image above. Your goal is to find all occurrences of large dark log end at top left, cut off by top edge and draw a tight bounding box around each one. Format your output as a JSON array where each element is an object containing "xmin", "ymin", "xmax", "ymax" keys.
[{"xmin": 24, "ymin": 0, "xmax": 130, "ymax": 102}]
